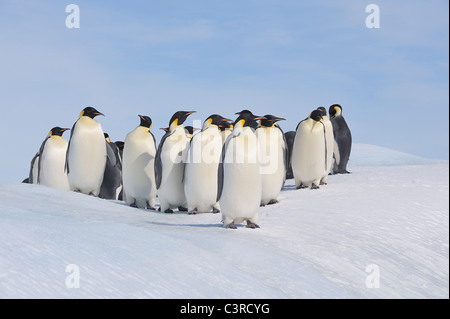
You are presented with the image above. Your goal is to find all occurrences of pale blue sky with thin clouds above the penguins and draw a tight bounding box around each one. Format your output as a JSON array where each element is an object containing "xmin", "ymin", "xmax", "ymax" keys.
[{"xmin": 0, "ymin": 0, "xmax": 449, "ymax": 182}]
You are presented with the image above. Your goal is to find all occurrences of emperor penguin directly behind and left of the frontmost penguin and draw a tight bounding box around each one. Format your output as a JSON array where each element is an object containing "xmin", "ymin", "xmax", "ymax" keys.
[{"xmin": 184, "ymin": 114, "xmax": 230, "ymax": 214}]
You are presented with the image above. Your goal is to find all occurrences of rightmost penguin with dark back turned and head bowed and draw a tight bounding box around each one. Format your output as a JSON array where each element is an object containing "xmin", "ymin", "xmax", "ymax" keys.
[{"xmin": 329, "ymin": 104, "xmax": 352, "ymax": 174}]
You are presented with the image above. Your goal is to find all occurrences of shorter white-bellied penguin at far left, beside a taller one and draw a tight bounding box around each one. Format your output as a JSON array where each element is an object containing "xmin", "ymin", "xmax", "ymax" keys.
[{"xmin": 37, "ymin": 126, "xmax": 70, "ymax": 190}]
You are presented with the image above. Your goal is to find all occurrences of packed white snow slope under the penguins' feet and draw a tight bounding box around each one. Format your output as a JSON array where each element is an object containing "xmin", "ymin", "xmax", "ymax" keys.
[{"xmin": 0, "ymin": 144, "xmax": 449, "ymax": 299}]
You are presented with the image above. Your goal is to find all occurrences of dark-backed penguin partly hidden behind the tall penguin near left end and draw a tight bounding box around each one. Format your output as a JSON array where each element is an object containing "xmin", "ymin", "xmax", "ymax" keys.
[{"xmin": 98, "ymin": 133, "xmax": 122, "ymax": 200}]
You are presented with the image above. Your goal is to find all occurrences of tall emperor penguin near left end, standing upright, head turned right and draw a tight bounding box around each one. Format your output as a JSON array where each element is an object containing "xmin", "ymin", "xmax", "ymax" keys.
[{"xmin": 66, "ymin": 106, "xmax": 110, "ymax": 196}]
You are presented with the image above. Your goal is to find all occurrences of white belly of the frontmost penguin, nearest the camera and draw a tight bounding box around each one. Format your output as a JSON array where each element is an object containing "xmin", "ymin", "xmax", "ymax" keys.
[{"xmin": 220, "ymin": 132, "xmax": 261, "ymax": 224}]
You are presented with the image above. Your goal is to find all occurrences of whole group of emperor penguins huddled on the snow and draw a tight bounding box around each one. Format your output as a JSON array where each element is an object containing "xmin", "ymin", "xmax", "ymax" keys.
[{"xmin": 24, "ymin": 104, "xmax": 352, "ymax": 229}]
